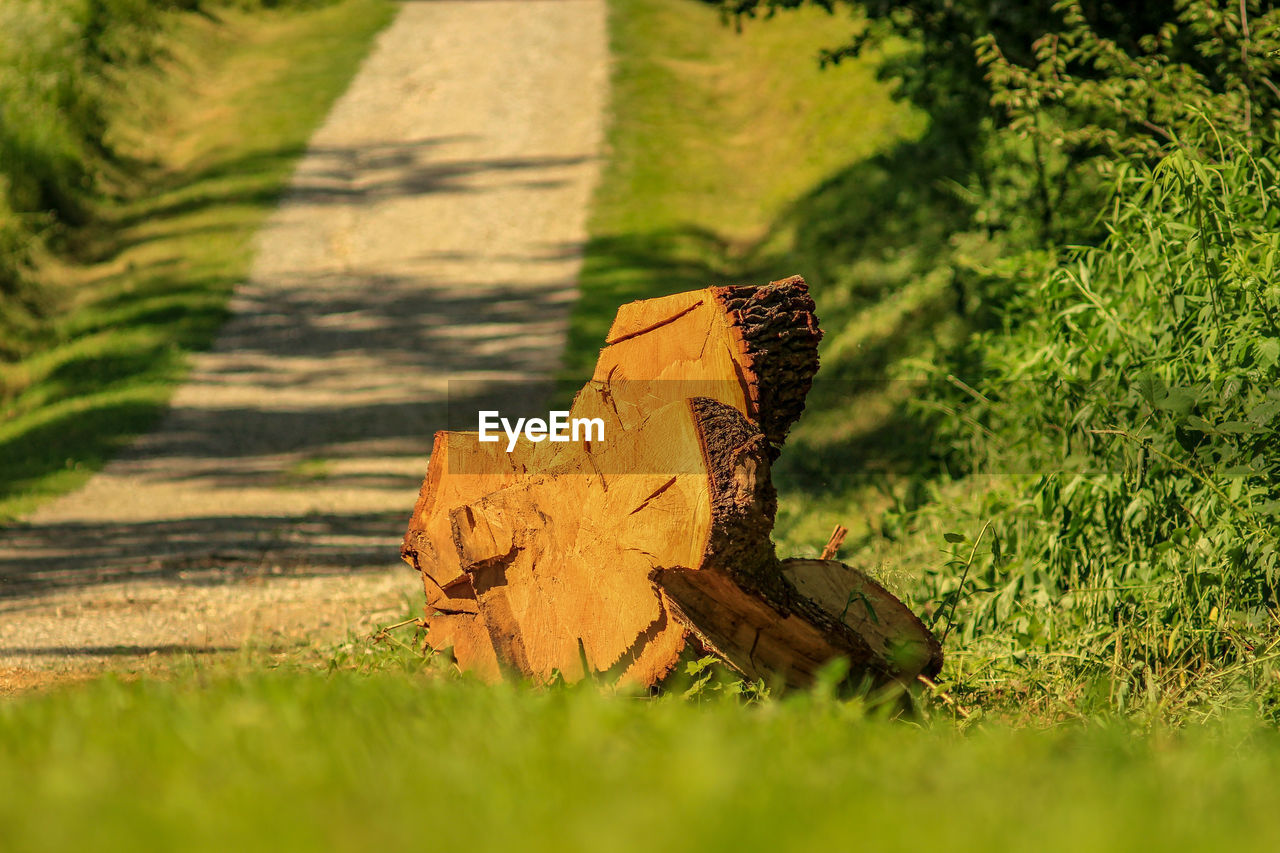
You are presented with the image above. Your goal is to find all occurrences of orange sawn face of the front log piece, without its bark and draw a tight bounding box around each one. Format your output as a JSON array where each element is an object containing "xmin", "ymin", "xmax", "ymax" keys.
[{"xmin": 452, "ymin": 401, "xmax": 716, "ymax": 685}]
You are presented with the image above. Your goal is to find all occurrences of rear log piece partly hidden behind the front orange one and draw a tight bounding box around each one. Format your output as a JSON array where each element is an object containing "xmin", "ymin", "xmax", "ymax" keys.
[{"xmin": 401, "ymin": 277, "xmax": 822, "ymax": 675}]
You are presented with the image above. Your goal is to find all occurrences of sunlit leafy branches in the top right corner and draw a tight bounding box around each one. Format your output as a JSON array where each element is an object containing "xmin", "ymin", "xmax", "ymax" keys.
[{"xmin": 975, "ymin": 0, "xmax": 1280, "ymax": 161}]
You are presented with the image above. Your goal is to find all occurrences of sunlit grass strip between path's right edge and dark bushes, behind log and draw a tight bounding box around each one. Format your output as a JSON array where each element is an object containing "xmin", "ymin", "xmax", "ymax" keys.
[{"xmin": 564, "ymin": 0, "xmax": 923, "ymax": 379}]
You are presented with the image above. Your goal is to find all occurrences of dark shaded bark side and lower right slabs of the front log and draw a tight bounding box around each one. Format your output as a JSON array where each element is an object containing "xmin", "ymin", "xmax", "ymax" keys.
[{"xmin": 653, "ymin": 401, "xmax": 942, "ymax": 686}]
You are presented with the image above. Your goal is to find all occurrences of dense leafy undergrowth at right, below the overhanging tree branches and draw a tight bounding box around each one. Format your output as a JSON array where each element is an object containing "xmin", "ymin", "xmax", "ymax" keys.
[{"xmin": 915, "ymin": 134, "xmax": 1280, "ymax": 706}]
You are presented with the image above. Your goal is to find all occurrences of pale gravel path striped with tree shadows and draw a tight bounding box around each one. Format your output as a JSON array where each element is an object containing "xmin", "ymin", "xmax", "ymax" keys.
[{"xmin": 0, "ymin": 0, "xmax": 607, "ymax": 689}]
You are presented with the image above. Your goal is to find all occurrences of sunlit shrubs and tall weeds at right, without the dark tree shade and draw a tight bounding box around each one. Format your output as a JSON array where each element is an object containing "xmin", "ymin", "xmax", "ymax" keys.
[{"xmin": 860, "ymin": 0, "xmax": 1280, "ymax": 715}]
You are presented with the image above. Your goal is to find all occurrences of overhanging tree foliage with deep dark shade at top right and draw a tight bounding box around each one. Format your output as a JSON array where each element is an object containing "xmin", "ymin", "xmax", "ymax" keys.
[{"xmin": 719, "ymin": 0, "xmax": 1280, "ymax": 268}]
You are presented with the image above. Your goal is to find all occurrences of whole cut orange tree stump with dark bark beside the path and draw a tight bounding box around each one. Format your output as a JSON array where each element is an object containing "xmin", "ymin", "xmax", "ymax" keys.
[{"xmin": 402, "ymin": 277, "xmax": 942, "ymax": 686}]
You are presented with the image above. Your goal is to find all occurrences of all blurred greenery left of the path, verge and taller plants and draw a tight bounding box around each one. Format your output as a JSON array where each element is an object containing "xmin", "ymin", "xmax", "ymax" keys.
[{"xmin": 0, "ymin": 0, "xmax": 394, "ymax": 520}]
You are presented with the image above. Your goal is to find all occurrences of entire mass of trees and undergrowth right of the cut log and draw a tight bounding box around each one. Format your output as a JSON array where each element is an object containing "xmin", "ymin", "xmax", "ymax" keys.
[{"xmin": 701, "ymin": 0, "xmax": 1280, "ymax": 719}]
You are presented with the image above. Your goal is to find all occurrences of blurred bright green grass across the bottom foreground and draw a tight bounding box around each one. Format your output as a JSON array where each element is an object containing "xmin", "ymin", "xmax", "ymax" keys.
[{"xmin": 0, "ymin": 648, "xmax": 1280, "ymax": 853}]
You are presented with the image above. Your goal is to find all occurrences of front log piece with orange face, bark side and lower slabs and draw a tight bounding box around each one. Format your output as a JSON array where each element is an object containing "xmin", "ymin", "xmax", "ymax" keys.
[{"xmin": 453, "ymin": 398, "xmax": 932, "ymax": 686}]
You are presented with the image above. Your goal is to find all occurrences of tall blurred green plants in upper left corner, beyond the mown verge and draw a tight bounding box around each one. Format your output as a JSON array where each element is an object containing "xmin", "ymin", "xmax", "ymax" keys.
[{"xmin": 0, "ymin": 0, "xmax": 335, "ymax": 361}]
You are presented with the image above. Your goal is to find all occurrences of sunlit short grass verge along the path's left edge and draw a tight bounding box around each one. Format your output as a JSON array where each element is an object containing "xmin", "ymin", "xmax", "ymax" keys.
[{"xmin": 0, "ymin": 0, "xmax": 394, "ymax": 519}]
